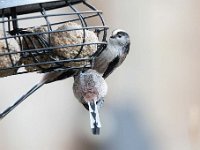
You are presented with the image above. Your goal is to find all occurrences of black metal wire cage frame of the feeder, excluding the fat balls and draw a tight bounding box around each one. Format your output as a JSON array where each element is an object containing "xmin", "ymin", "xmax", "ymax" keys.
[{"xmin": 0, "ymin": 0, "xmax": 108, "ymax": 75}]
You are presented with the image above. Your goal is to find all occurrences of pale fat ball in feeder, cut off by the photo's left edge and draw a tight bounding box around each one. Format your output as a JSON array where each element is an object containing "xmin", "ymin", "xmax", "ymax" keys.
[{"xmin": 0, "ymin": 30, "xmax": 20, "ymax": 77}]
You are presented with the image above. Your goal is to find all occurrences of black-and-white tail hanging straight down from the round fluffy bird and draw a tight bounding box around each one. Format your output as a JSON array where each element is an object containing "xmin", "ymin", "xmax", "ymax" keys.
[{"xmin": 88, "ymin": 102, "xmax": 101, "ymax": 135}]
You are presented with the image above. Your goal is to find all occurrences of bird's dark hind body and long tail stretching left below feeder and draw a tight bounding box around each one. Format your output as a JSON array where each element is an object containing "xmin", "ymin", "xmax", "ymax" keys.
[{"xmin": 0, "ymin": 69, "xmax": 78, "ymax": 120}]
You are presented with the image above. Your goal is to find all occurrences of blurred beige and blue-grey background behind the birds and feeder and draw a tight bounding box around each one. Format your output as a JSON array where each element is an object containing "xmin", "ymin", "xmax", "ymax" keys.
[{"xmin": 0, "ymin": 0, "xmax": 200, "ymax": 150}]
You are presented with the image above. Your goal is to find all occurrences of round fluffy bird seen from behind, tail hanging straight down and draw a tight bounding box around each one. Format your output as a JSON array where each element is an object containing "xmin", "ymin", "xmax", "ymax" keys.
[{"xmin": 73, "ymin": 69, "xmax": 107, "ymax": 134}]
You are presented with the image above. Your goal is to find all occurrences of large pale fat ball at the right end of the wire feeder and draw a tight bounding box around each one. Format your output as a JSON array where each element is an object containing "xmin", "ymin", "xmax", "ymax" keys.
[{"xmin": 51, "ymin": 22, "xmax": 98, "ymax": 67}]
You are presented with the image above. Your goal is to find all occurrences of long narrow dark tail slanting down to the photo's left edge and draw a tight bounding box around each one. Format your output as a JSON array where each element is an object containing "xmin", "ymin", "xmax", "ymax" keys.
[{"xmin": 0, "ymin": 82, "xmax": 44, "ymax": 120}]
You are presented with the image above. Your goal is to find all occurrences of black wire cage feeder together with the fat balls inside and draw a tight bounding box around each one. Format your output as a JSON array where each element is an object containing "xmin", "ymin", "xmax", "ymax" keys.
[{"xmin": 0, "ymin": 0, "xmax": 108, "ymax": 77}]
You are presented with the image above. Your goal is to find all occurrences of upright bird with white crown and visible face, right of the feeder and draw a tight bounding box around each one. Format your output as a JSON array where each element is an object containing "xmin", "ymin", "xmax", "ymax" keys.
[{"xmin": 93, "ymin": 29, "xmax": 130, "ymax": 78}]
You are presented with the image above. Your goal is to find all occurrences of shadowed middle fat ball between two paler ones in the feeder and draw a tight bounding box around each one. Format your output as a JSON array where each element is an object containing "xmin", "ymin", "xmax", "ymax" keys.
[{"xmin": 21, "ymin": 26, "xmax": 52, "ymax": 72}]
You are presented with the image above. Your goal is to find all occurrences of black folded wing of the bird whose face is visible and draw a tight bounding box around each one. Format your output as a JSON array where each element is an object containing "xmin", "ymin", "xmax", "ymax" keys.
[{"xmin": 103, "ymin": 56, "xmax": 120, "ymax": 79}]
